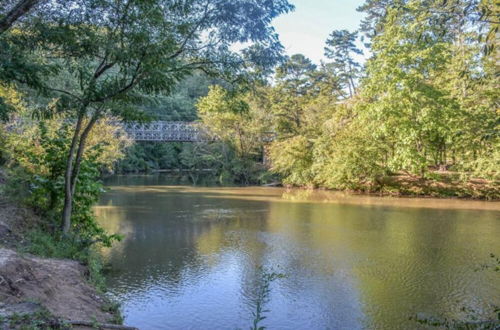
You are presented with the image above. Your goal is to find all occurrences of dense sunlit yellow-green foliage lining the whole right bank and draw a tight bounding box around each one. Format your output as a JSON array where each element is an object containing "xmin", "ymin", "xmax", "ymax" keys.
[{"xmin": 192, "ymin": 0, "xmax": 500, "ymax": 197}]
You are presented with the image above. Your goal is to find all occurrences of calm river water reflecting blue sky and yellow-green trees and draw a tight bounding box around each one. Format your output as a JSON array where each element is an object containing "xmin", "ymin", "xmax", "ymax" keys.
[{"xmin": 96, "ymin": 176, "xmax": 500, "ymax": 330}]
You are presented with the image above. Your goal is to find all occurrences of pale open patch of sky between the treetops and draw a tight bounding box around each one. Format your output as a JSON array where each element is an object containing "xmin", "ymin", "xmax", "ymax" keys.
[{"xmin": 273, "ymin": 0, "xmax": 364, "ymax": 64}]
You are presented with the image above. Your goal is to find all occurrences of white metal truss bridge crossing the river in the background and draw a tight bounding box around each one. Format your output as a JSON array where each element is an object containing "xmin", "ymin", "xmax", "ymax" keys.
[{"xmin": 121, "ymin": 121, "xmax": 213, "ymax": 142}]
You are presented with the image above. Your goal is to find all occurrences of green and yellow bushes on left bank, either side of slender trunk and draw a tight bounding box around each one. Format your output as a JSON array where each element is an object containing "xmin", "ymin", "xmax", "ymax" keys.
[{"xmin": 2, "ymin": 112, "xmax": 130, "ymax": 246}]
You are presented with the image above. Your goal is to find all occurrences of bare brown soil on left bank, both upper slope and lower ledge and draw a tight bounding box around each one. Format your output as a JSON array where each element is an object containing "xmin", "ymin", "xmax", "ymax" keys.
[{"xmin": 0, "ymin": 168, "xmax": 127, "ymax": 330}]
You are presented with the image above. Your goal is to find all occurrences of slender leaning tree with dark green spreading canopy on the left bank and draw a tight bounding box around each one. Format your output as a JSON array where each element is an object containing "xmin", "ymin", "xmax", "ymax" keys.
[{"xmin": 6, "ymin": 0, "xmax": 293, "ymax": 233}]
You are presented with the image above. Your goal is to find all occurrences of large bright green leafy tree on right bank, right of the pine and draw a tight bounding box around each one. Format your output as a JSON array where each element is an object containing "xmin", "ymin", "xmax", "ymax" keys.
[{"xmin": 360, "ymin": 2, "xmax": 459, "ymax": 174}]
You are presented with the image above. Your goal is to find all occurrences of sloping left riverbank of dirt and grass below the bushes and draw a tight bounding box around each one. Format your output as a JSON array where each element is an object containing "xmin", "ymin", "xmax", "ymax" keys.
[{"xmin": 0, "ymin": 173, "xmax": 132, "ymax": 329}]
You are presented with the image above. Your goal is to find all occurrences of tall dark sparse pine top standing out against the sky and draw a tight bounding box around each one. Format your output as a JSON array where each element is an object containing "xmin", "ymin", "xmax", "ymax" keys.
[{"xmin": 325, "ymin": 30, "xmax": 363, "ymax": 97}]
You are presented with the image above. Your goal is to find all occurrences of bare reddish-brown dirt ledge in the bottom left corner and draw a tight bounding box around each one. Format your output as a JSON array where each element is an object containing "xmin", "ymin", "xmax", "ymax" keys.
[{"xmin": 0, "ymin": 248, "xmax": 114, "ymax": 323}]
